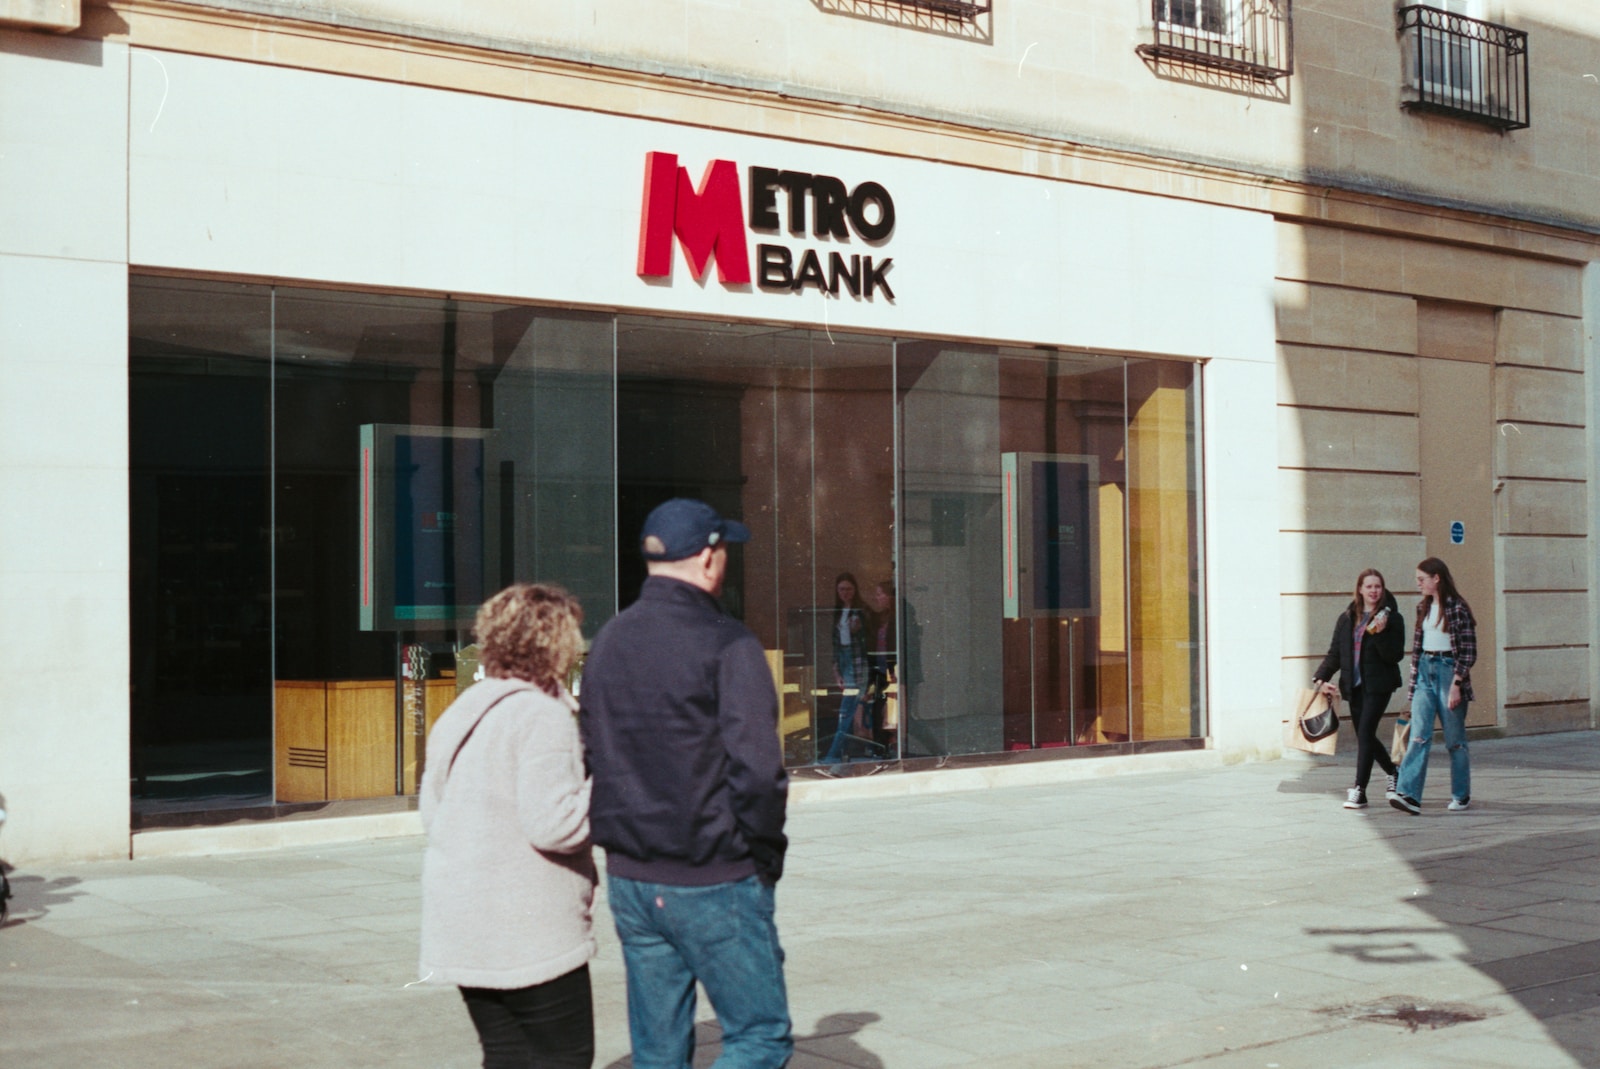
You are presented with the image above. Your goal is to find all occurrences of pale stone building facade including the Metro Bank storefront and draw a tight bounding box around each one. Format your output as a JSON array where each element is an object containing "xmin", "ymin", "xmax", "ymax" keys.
[{"xmin": 0, "ymin": 0, "xmax": 1600, "ymax": 859}]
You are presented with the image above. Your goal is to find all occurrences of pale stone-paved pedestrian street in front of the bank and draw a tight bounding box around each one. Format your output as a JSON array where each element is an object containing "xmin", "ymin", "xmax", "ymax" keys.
[{"xmin": 0, "ymin": 733, "xmax": 1600, "ymax": 1069}]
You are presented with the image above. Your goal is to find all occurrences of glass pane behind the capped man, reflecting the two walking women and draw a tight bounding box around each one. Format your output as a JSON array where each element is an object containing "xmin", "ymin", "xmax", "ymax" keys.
[{"xmin": 618, "ymin": 317, "xmax": 898, "ymax": 765}]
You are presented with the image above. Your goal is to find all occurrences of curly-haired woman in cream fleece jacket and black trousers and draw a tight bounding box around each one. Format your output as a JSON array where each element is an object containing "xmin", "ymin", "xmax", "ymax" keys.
[{"xmin": 419, "ymin": 583, "xmax": 595, "ymax": 1069}]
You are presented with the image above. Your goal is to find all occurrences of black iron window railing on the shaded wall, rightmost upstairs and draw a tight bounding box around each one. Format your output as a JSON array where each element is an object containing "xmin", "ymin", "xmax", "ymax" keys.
[{"xmin": 1400, "ymin": 5, "xmax": 1531, "ymax": 130}]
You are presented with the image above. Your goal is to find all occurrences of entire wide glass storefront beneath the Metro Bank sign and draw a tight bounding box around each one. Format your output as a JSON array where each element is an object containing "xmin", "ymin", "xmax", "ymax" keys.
[{"xmin": 130, "ymin": 277, "xmax": 1206, "ymax": 815}]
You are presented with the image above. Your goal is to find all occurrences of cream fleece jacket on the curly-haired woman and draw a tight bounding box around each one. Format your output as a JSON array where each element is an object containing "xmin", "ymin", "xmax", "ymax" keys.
[{"xmin": 419, "ymin": 679, "xmax": 595, "ymax": 989}]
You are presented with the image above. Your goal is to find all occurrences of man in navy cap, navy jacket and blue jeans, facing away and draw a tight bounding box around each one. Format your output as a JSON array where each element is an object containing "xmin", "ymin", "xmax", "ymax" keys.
[{"xmin": 581, "ymin": 498, "xmax": 794, "ymax": 1069}]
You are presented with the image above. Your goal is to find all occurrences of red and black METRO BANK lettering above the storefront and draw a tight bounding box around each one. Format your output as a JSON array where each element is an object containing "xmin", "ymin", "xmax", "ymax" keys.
[{"xmin": 638, "ymin": 152, "xmax": 894, "ymax": 301}]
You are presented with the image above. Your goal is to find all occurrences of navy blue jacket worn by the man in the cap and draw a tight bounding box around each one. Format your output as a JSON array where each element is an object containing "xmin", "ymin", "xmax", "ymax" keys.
[{"xmin": 581, "ymin": 576, "xmax": 789, "ymax": 887}]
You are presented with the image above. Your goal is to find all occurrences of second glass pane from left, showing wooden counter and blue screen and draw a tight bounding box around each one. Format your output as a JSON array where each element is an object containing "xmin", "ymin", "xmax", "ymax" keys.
[{"xmin": 274, "ymin": 290, "xmax": 614, "ymax": 802}]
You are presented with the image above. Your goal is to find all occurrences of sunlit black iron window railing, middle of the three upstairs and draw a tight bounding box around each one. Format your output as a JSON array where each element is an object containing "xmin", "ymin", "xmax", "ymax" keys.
[{"xmin": 1138, "ymin": 0, "xmax": 1294, "ymax": 82}]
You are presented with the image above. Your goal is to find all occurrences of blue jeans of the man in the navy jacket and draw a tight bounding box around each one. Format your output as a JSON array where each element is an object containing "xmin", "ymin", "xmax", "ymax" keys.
[{"xmin": 606, "ymin": 874, "xmax": 795, "ymax": 1069}]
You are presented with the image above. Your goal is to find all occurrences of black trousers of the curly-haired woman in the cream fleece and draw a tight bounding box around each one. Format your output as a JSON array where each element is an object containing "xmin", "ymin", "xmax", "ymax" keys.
[{"xmin": 461, "ymin": 965, "xmax": 595, "ymax": 1069}]
